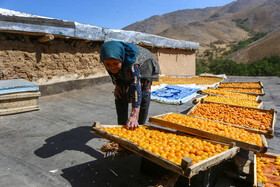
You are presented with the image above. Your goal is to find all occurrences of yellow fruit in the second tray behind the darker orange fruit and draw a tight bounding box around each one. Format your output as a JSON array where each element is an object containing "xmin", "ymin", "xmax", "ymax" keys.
[{"xmin": 202, "ymin": 89, "xmax": 257, "ymax": 100}]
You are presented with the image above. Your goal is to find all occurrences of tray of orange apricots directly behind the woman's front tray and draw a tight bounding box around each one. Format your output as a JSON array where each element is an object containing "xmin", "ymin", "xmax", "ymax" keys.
[{"xmin": 149, "ymin": 113, "xmax": 267, "ymax": 153}]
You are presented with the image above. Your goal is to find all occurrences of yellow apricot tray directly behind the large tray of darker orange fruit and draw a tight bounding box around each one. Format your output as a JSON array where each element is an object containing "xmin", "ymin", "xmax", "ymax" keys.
[{"xmin": 193, "ymin": 95, "xmax": 263, "ymax": 108}]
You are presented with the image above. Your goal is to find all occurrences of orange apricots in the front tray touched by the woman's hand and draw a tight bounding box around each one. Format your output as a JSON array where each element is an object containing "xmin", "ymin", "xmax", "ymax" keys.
[{"xmin": 103, "ymin": 126, "xmax": 229, "ymax": 165}]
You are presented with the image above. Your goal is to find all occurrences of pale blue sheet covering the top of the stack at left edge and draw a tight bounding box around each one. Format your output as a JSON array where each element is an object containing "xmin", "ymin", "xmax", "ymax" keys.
[{"xmin": 0, "ymin": 79, "xmax": 39, "ymax": 94}]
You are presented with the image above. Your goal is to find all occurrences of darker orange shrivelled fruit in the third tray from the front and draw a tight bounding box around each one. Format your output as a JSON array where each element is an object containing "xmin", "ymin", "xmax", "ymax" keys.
[{"xmin": 189, "ymin": 103, "xmax": 273, "ymax": 130}]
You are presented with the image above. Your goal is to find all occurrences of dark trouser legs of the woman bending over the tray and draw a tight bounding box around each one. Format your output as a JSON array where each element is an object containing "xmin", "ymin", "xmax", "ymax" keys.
[{"xmin": 115, "ymin": 92, "xmax": 151, "ymax": 125}]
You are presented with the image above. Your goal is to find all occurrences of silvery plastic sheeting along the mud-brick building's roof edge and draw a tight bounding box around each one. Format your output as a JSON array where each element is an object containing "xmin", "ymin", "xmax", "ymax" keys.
[{"xmin": 0, "ymin": 8, "xmax": 199, "ymax": 50}]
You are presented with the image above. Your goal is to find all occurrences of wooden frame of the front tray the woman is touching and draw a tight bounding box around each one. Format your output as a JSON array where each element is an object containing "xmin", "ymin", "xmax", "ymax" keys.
[{"xmin": 91, "ymin": 122, "xmax": 239, "ymax": 178}]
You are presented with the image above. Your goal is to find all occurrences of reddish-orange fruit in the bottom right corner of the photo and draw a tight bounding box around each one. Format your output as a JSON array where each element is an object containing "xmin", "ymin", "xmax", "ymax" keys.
[{"xmin": 257, "ymin": 155, "xmax": 280, "ymax": 186}]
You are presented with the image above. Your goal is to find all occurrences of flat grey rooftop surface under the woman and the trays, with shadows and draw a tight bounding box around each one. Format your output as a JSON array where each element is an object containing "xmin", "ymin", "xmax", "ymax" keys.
[{"xmin": 0, "ymin": 76, "xmax": 280, "ymax": 187}]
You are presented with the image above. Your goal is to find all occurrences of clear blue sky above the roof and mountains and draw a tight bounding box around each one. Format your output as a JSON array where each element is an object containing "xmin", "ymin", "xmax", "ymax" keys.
[{"xmin": 0, "ymin": 0, "xmax": 234, "ymax": 29}]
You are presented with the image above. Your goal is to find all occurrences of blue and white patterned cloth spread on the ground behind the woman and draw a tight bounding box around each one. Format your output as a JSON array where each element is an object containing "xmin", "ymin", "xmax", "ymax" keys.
[{"xmin": 151, "ymin": 85, "xmax": 200, "ymax": 104}]
